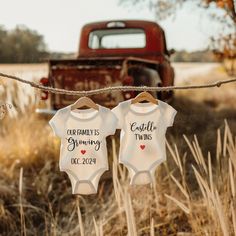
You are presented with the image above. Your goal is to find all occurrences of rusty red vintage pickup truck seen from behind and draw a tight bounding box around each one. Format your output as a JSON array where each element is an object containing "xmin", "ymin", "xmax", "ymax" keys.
[{"xmin": 36, "ymin": 20, "xmax": 174, "ymax": 114}]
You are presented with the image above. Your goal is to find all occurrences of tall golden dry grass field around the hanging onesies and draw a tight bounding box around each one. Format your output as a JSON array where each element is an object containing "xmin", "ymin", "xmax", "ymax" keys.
[{"xmin": 0, "ymin": 63, "xmax": 236, "ymax": 236}]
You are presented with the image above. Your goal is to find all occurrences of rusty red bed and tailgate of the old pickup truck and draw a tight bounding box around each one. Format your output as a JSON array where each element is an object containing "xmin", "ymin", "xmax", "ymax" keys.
[{"xmin": 49, "ymin": 57, "xmax": 157, "ymax": 110}]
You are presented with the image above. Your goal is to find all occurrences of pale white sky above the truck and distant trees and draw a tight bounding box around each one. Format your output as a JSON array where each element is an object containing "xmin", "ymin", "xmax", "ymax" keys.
[{"xmin": 0, "ymin": 0, "xmax": 225, "ymax": 52}]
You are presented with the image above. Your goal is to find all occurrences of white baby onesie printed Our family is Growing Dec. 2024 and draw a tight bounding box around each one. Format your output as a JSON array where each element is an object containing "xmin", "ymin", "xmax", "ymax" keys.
[{"xmin": 49, "ymin": 105, "xmax": 118, "ymax": 194}]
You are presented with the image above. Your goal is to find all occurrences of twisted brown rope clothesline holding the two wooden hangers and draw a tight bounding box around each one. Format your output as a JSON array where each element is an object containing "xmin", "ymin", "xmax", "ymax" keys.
[{"xmin": 0, "ymin": 72, "xmax": 236, "ymax": 96}]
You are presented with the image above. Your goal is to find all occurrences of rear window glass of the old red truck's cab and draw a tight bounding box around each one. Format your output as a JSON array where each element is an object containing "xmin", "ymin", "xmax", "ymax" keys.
[{"xmin": 88, "ymin": 28, "xmax": 146, "ymax": 49}]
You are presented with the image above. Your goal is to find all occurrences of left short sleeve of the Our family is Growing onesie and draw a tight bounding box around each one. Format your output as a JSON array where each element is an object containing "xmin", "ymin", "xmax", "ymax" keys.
[{"xmin": 48, "ymin": 110, "xmax": 65, "ymax": 138}]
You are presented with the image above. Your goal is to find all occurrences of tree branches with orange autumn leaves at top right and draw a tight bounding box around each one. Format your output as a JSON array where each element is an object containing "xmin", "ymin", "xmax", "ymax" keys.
[{"xmin": 120, "ymin": 0, "xmax": 236, "ymax": 73}]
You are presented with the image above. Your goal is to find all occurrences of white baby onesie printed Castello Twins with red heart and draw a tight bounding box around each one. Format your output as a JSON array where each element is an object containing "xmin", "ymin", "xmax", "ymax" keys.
[{"xmin": 112, "ymin": 99, "xmax": 177, "ymax": 185}]
